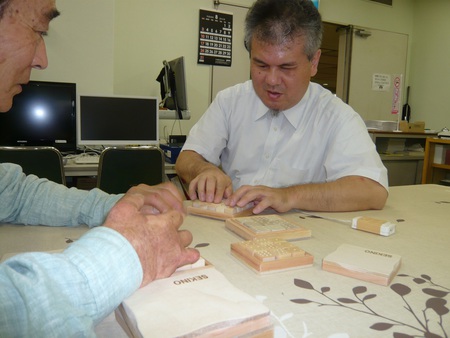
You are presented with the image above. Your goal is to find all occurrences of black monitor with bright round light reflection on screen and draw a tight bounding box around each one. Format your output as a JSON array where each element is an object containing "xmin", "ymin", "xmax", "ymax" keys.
[{"xmin": 0, "ymin": 81, "xmax": 76, "ymax": 152}]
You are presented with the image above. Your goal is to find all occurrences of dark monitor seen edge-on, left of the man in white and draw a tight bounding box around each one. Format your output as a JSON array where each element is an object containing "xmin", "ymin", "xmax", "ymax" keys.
[{"xmin": 157, "ymin": 56, "xmax": 190, "ymax": 119}]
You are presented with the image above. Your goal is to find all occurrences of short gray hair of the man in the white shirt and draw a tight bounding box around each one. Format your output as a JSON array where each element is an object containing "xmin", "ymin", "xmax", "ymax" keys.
[{"xmin": 244, "ymin": 0, "xmax": 323, "ymax": 60}]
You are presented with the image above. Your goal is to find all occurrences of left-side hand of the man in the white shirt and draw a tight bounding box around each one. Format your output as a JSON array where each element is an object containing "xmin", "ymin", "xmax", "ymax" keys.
[{"xmin": 189, "ymin": 167, "xmax": 233, "ymax": 203}]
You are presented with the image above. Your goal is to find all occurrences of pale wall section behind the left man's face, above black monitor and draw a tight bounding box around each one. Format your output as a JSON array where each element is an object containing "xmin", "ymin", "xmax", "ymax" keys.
[{"xmin": 31, "ymin": 0, "xmax": 114, "ymax": 94}]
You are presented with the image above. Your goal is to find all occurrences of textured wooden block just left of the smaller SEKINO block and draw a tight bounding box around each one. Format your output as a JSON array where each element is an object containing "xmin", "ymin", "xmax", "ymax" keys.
[{"xmin": 231, "ymin": 238, "xmax": 314, "ymax": 273}]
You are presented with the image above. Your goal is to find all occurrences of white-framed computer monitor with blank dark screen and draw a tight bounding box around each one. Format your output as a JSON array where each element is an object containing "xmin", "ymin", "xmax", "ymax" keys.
[{"xmin": 77, "ymin": 95, "xmax": 159, "ymax": 146}]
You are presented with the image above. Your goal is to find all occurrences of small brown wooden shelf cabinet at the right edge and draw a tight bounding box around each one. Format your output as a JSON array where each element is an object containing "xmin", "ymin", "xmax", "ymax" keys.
[{"xmin": 422, "ymin": 138, "xmax": 450, "ymax": 184}]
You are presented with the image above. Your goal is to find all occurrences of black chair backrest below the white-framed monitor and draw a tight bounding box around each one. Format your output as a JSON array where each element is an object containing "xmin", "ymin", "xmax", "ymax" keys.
[{"xmin": 97, "ymin": 147, "xmax": 165, "ymax": 194}]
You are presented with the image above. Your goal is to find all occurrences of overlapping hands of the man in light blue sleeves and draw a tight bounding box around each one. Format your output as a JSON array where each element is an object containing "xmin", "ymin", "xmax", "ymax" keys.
[{"xmin": 104, "ymin": 183, "xmax": 200, "ymax": 286}]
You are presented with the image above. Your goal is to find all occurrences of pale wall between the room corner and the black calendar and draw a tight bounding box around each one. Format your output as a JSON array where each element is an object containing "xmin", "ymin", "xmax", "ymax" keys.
[{"xmin": 114, "ymin": 0, "xmax": 212, "ymax": 137}]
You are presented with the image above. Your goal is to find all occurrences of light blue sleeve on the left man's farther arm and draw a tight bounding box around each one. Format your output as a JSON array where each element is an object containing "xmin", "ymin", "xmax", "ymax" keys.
[{"xmin": 0, "ymin": 163, "xmax": 122, "ymax": 227}]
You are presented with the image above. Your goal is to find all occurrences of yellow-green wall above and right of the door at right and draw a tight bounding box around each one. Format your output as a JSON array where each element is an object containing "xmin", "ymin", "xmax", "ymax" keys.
[{"xmin": 320, "ymin": 0, "xmax": 450, "ymax": 131}]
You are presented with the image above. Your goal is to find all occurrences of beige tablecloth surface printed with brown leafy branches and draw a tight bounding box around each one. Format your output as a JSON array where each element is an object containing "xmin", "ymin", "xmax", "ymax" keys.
[{"xmin": 0, "ymin": 185, "xmax": 450, "ymax": 337}]
